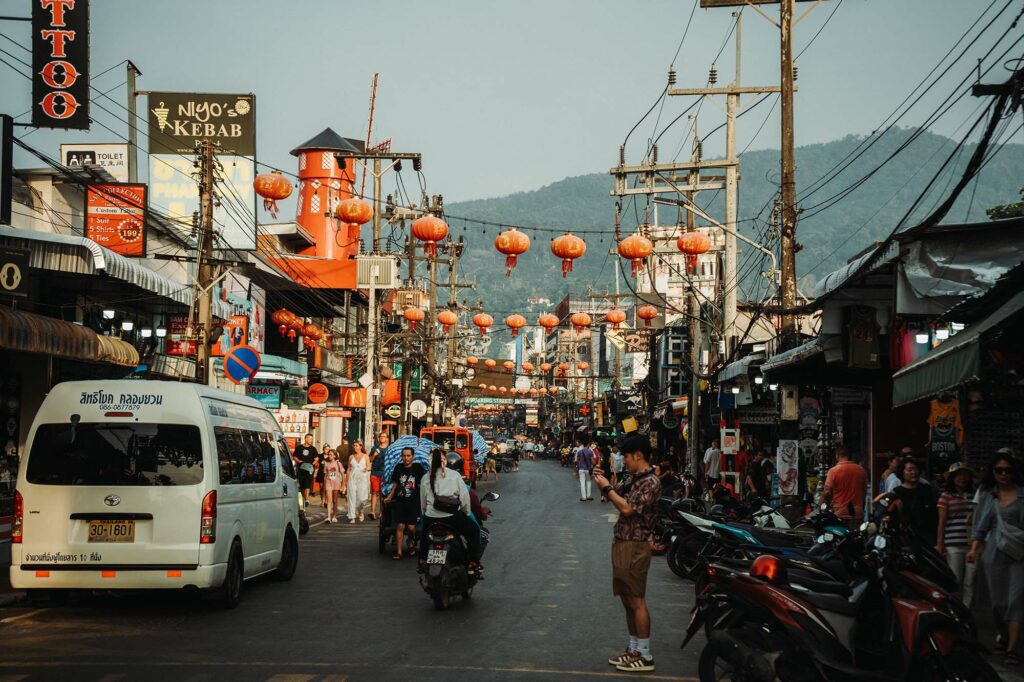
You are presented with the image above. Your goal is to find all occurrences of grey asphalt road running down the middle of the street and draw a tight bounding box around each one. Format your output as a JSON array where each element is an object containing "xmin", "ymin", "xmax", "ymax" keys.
[{"xmin": 0, "ymin": 462, "xmax": 700, "ymax": 682}]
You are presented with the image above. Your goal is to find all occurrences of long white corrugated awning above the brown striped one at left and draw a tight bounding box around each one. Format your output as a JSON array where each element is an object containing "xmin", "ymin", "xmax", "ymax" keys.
[{"xmin": 0, "ymin": 226, "xmax": 232, "ymax": 319}]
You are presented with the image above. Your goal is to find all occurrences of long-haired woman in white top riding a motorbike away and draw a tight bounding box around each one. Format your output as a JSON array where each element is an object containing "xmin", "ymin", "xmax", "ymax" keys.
[{"xmin": 420, "ymin": 447, "xmax": 480, "ymax": 572}]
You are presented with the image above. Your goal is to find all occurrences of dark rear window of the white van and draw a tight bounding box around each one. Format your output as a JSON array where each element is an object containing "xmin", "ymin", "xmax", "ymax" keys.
[{"xmin": 26, "ymin": 422, "xmax": 203, "ymax": 485}]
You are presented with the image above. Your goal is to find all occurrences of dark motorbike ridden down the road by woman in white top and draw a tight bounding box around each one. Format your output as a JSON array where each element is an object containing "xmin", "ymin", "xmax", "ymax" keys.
[{"xmin": 420, "ymin": 492, "xmax": 501, "ymax": 611}]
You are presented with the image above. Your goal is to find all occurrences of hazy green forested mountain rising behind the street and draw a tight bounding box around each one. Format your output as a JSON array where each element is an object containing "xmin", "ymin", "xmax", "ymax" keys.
[{"xmin": 445, "ymin": 129, "xmax": 1024, "ymax": 309}]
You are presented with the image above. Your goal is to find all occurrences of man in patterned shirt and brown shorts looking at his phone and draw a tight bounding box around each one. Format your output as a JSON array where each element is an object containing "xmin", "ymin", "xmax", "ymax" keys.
[{"xmin": 594, "ymin": 435, "xmax": 662, "ymax": 672}]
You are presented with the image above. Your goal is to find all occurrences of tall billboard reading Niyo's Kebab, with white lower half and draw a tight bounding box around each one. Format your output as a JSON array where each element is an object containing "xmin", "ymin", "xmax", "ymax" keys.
[{"xmin": 147, "ymin": 92, "xmax": 256, "ymax": 251}]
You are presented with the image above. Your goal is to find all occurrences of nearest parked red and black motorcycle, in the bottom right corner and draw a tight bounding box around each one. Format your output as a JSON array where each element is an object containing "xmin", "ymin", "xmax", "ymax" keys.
[{"xmin": 683, "ymin": 499, "xmax": 999, "ymax": 682}]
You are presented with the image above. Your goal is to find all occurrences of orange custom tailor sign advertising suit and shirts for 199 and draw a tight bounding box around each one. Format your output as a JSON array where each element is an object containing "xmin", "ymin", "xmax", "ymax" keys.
[{"xmin": 85, "ymin": 184, "xmax": 145, "ymax": 256}]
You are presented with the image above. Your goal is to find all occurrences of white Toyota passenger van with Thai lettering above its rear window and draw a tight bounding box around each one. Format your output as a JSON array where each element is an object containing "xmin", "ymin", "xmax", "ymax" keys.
[{"xmin": 10, "ymin": 381, "xmax": 299, "ymax": 607}]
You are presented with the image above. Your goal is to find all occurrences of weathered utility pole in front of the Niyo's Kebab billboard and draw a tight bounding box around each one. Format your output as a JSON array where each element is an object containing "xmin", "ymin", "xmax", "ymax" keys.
[{"xmin": 196, "ymin": 139, "xmax": 216, "ymax": 384}]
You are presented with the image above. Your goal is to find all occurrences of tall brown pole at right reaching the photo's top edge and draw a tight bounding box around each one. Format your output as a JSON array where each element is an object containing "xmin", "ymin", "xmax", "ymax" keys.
[{"xmin": 779, "ymin": 0, "xmax": 797, "ymax": 337}]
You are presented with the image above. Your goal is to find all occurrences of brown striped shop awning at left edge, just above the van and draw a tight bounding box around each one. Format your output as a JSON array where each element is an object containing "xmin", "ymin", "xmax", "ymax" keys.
[{"xmin": 0, "ymin": 307, "xmax": 138, "ymax": 367}]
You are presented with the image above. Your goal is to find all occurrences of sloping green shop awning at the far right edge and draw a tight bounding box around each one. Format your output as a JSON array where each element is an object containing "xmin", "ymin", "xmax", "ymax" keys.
[{"xmin": 893, "ymin": 292, "xmax": 1024, "ymax": 408}]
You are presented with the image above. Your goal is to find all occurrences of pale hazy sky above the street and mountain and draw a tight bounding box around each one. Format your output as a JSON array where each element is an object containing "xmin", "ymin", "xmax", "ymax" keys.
[{"xmin": 0, "ymin": 0, "xmax": 1024, "ymax": 201}]
